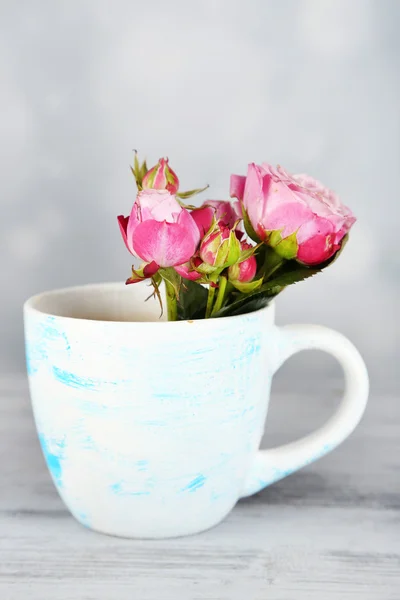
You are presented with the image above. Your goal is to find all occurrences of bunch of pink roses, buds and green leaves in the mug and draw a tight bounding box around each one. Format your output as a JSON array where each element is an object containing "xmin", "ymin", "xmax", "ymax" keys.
[{"xmin": 118, "ymin": 153, "xmax": 356, "ymax": 321}]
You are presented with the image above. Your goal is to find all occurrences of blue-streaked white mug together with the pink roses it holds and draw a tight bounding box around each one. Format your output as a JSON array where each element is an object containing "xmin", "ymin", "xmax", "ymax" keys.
[{"xmin": 24, "ymin": 150, "xmax": 368, "ymax": 538}]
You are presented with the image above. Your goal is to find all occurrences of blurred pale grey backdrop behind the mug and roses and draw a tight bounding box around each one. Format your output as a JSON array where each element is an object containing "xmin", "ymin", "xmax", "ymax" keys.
[{"xmin": 0, "ymin": 0, "xmax": 400, "ymax": 389}]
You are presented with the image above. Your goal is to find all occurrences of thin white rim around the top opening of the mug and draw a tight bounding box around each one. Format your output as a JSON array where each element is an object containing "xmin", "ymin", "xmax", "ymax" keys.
[{"xmin": 23, "ymin": 281, "xmax": 275, "ymax": 326}]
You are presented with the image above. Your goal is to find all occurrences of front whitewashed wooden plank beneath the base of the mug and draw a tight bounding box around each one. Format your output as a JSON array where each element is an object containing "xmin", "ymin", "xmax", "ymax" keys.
[{"xmin": 0, "ymin": 505, "xmax": 400, "ymax": 600}]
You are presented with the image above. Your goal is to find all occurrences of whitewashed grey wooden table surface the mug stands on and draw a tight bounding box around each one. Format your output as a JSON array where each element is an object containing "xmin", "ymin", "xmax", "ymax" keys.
[{"xmin": 0, "ymin": 377, "xmax": 400, "ymax": 600}]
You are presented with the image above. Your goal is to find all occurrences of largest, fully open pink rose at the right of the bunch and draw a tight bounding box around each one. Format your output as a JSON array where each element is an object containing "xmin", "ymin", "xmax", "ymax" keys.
[{"xmin": 231, "ymin": 163, "xmax": 356, "ymax": 265}]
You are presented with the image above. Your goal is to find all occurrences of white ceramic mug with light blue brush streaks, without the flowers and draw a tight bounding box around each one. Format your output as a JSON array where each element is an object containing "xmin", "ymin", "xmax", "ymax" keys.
[{"xmin": 24, "ymin": 284, "xmax": 368, "ymax": 538}]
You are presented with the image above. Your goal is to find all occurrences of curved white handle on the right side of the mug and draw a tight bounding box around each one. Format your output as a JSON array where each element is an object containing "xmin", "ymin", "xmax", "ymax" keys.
[{"xmin": 240, "ymin": 325, "xmax": 369, "ymax": 498}]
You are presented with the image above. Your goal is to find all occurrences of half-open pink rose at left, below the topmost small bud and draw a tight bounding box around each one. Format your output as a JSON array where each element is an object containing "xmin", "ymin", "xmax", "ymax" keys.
[{"xmin": 118, "ymin": 190, "xmax": 200, "ymax": 267}]
